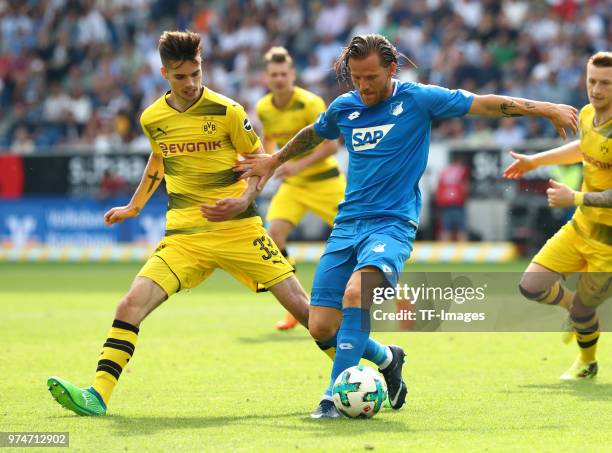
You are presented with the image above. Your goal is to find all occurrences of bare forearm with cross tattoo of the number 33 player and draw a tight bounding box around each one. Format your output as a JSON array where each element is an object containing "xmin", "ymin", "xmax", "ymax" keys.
[{"xmin": 104, "ymin": 153, "xmax": 164, "ymax": 225}]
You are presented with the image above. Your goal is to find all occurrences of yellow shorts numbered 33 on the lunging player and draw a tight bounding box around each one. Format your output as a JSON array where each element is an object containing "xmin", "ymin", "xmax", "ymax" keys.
[{"xmin": 138, "ymin": 224, "xmax": 293, "ymax": 296}]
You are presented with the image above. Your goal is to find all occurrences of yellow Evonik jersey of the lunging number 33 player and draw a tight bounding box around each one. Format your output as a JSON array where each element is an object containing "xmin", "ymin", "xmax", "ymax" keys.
[{"xmin": 140, "ymin": 87, "xmax": 261, "ymax": 235}]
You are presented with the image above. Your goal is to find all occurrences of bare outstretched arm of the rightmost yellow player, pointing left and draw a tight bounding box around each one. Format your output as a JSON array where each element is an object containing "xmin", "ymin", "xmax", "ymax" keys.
[{"xmin": 504, "ymin": 140, "xmax": 582, "ymax": 179}]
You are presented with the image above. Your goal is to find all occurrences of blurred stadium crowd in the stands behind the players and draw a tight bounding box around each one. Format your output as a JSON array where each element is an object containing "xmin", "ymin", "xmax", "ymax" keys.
[{"xmin": 0, "ymin": 0, "xmax": 612, "ymax": 154}]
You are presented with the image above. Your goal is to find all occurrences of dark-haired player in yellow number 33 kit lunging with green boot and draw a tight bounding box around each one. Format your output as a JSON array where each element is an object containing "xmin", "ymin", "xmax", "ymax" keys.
[{"xmin": 47, "ymin": 32, "xmax": 308, "ymax": 415}]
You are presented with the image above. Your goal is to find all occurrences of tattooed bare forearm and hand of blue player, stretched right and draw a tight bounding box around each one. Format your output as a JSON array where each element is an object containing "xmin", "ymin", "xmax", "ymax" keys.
[{"xmin": 468, "ymin": 94, "xmax": 578, "ymax": 140}]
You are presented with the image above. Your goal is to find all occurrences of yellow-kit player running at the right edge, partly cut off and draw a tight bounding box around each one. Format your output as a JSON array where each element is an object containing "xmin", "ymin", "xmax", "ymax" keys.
[{"xmin": 504, "ymin": 52, "xmax": 612, "ymax": 380}]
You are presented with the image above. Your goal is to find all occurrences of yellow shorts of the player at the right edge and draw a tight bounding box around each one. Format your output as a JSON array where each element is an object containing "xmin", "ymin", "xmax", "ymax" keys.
[{"xmin": 532, "ymin": 216, "xmax": 612, "ymax": 307}]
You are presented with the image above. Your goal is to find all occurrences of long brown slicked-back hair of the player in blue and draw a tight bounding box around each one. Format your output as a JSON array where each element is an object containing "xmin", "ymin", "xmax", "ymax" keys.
[{"xmin": 334, "ymin": 34, "xmax": 416, "ymax": 79}]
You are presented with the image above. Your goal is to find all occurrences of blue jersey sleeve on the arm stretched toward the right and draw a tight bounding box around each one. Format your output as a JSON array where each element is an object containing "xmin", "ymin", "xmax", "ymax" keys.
[{"xmin": 417, "ymin": 85, "xmax": 474, "ymax": 119}]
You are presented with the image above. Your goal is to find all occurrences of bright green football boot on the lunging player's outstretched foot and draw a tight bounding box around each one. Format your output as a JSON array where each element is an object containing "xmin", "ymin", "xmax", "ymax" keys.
[{"xmin": 47, "ymin": 376, "xmax": 106, "ymax": 415}]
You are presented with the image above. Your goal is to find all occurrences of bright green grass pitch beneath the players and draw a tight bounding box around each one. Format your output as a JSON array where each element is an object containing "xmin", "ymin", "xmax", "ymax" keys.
[{"xmin": 0, "ymin": 262, "xmax": 612, "ymax": 452}]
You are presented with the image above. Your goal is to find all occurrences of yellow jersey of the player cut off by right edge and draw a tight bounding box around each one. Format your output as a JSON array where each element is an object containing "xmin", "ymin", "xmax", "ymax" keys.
[{"xmin": 579, "ymin": 104, "xmax": 612, "ymax": 226}]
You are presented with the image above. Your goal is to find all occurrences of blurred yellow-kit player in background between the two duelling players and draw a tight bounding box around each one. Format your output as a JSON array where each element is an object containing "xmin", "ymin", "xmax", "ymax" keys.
[{"xmin": 256, "ymin": 47, "xmax": 346, "ymax": 330}]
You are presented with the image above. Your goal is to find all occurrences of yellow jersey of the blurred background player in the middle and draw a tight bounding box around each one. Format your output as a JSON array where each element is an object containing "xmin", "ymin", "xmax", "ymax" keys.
[{"xmin": 255, "ymin": 87, "xmax": 340, "ymax": 185}]
